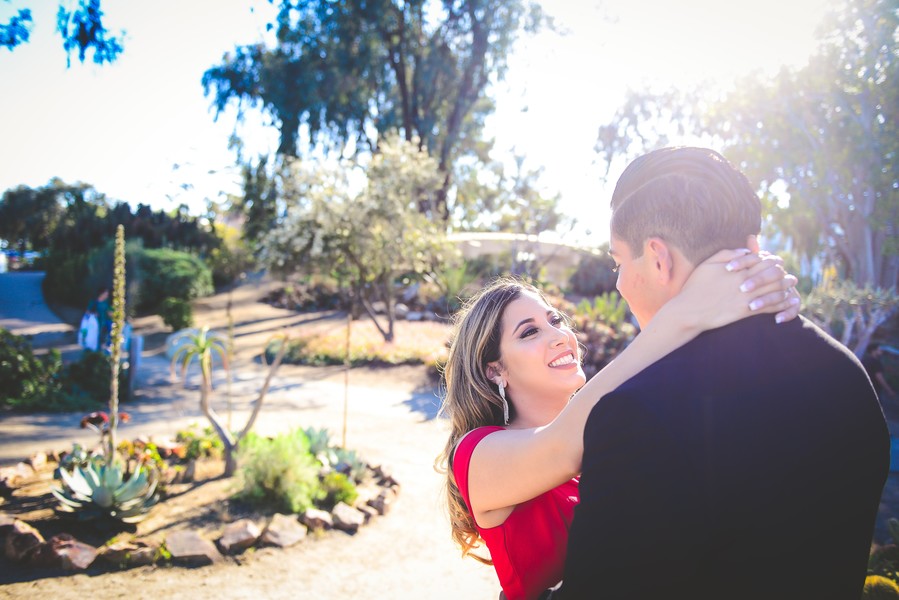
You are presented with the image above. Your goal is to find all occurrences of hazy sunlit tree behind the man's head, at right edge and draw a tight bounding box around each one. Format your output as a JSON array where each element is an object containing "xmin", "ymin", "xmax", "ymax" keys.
[{"xmin": 597, "ymin": 0, "xmax": 899, "ymax": 288}]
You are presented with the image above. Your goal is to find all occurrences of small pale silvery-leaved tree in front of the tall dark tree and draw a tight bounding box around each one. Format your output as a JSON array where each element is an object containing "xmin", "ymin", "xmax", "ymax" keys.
[{"xmin": 264, "ymin": 134, "xmax": 453, "ymax": 342}]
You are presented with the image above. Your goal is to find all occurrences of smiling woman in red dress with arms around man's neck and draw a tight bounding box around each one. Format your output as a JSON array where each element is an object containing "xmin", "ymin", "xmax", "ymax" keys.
[{"xmin": 439, "ymin": 251, "xmax": 799, "ymax": 599}]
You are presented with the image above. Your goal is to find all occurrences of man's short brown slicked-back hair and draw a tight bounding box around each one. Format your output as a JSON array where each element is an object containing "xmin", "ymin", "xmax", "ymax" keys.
[{"xmin": 611, "ymin": 147, "xmax": 762, "ymax": 264}]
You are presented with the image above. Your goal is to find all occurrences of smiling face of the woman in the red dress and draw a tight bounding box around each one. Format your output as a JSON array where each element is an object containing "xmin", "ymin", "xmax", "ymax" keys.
[{"xmin": 488, "ymin": 291, "xmax": 586, "ymax": 412}]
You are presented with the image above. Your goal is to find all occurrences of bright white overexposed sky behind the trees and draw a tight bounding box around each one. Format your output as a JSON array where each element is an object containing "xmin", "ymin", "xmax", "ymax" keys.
[{"xmin": 0, "ymin": 0, "xmax": 829, "ymax": 245}]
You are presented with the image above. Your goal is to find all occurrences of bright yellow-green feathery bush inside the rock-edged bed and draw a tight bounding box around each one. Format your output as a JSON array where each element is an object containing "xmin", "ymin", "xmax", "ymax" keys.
[{"xmin": 237, "ymin": 429, "xmax": 325, "ymax": 513}]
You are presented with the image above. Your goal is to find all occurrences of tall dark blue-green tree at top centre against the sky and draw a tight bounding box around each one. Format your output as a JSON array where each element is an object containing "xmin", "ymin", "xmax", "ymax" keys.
[{"xmin": 203, "ymin": 0, "xmax": 547, "ymax": 224}]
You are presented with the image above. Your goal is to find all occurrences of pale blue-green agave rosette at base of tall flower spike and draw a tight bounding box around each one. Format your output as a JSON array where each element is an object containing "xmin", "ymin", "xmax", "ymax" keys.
[{"xmin": 51, "ymin": 460, "xmax": 157, "ymax": 523}]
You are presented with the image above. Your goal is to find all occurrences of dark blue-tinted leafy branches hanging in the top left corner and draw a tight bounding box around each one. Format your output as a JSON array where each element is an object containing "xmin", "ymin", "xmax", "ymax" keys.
[{"xmin": 0, "ymin": 0, "xmax": 122, "ymax": 66}]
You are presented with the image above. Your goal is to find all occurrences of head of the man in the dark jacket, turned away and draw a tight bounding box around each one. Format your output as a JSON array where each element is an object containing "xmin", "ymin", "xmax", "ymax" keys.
[{"xmin": 611, "ymin": 147, "xmax": 761, "ymax": 326}]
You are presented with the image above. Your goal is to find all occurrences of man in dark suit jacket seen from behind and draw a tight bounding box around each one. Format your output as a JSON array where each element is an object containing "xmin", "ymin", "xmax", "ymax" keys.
[{"xmin": 553, "ymin": 148, "xmax": 890, "ymax": 600}]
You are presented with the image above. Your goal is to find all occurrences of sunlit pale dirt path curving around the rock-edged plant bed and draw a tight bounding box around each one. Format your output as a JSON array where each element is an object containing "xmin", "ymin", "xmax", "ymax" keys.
[{"xmin": 0, "ymin": 278, "xmax": 499, "ymax": 600}]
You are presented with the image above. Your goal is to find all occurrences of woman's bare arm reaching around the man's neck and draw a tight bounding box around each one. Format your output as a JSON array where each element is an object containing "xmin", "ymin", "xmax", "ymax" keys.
[{"xmin": 468, "ymin": 251, "xmax": 798, "ymax": 527}]
